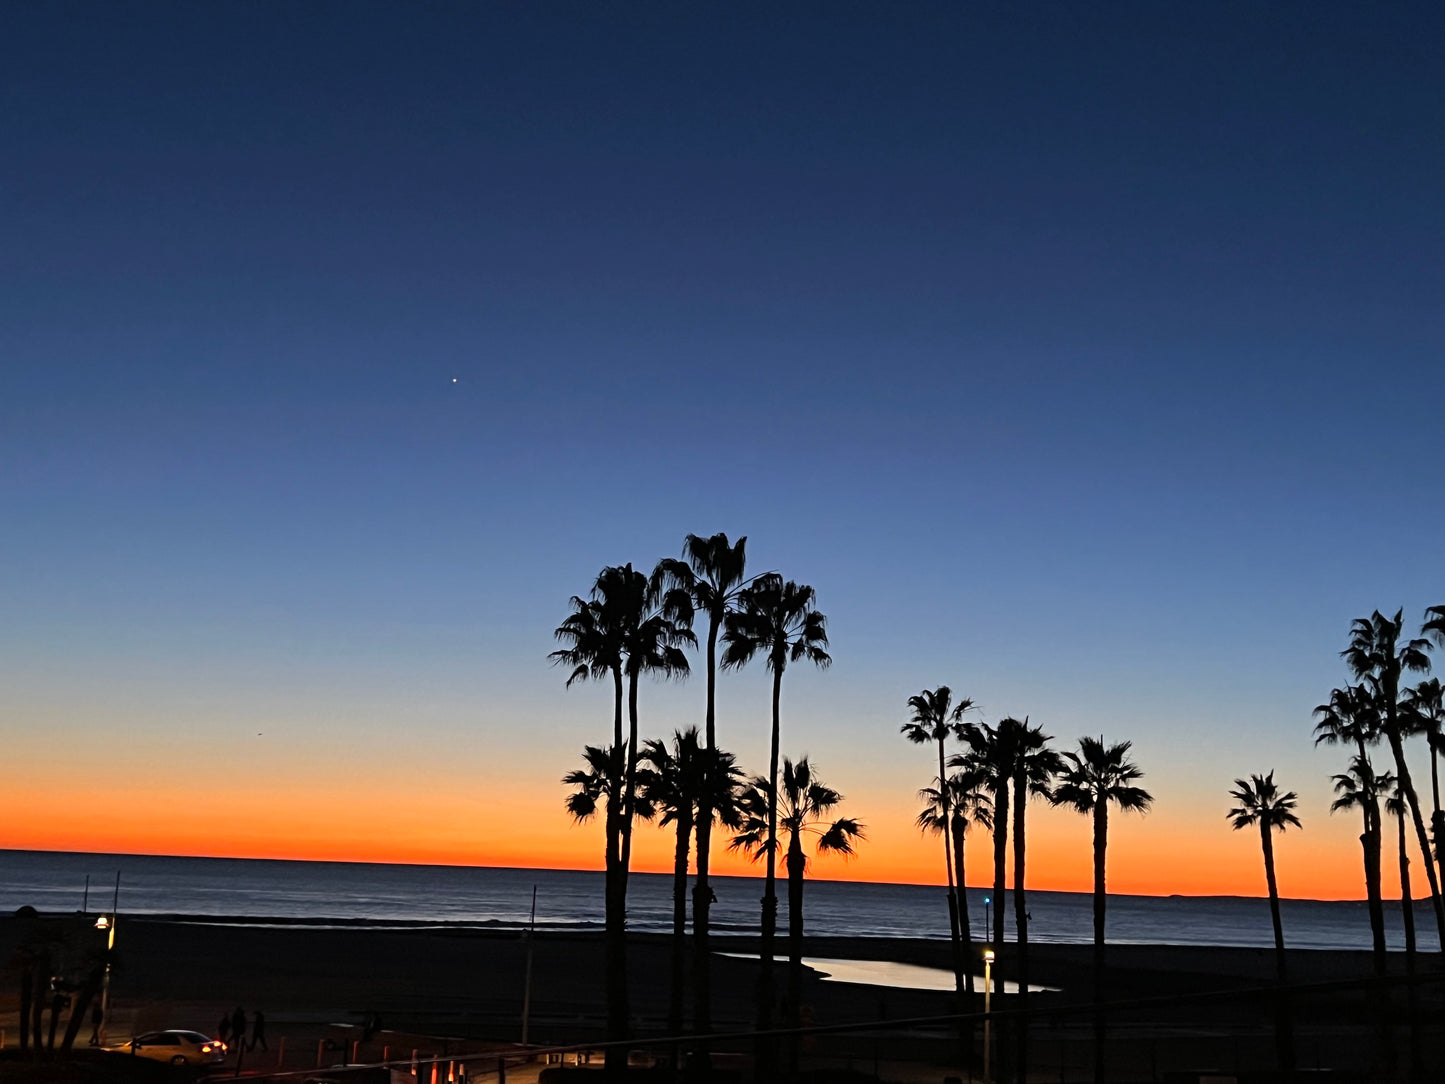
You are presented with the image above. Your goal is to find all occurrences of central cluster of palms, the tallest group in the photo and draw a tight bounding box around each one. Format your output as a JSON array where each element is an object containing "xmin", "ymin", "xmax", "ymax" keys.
[{"xmin": 551, "ymin": 533, "xmax": 863, "ymax": 1070}]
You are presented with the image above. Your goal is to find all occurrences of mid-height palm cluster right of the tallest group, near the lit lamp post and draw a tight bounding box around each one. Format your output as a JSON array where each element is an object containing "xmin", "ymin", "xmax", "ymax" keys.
[{"xmin": 902, "ymin": 685, "xmax": 1153, "ymax": 994}]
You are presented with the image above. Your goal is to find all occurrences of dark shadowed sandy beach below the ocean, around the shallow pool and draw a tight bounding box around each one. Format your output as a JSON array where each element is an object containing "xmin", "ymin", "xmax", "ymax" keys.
[{"xmin": 0, "ymin": 918, "xmax": 1441, "ymax": 1080}]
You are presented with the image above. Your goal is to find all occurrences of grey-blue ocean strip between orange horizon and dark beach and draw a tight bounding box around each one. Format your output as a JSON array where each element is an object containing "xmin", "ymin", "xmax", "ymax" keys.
[{"xmin": 0, "ymin": 850, "xmax": 1438, "ymax": 951}]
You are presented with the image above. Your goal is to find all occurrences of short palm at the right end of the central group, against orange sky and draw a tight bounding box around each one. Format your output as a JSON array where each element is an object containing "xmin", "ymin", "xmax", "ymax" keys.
[{"xmin": 730, "ymin": 757, "xmax": 864, "ymax": 1063}]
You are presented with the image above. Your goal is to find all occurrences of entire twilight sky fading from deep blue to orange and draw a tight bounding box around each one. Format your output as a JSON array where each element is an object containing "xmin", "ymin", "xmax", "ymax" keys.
[{"xmin": 0, "ymin": 3, "xmax": 1445, "ymax": 898}]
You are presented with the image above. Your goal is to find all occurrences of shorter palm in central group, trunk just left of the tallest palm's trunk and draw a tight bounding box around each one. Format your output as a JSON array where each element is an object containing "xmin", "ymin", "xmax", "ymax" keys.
[{"xmin": 637, "ymin": 727, "xmax": 743, "ymax": 1049}]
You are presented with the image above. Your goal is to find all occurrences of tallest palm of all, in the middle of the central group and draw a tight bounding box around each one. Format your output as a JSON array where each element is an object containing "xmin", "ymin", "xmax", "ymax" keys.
[{"xmin": 657, "ymin": 532, "xmax": 751, "ymax": 1035}]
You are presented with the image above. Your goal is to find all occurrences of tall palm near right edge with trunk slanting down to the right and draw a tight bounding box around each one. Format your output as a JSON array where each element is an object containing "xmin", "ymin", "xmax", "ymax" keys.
[{"xmin": 1341, "ymin": 610, "xmax": 1445, "ymax": 945}]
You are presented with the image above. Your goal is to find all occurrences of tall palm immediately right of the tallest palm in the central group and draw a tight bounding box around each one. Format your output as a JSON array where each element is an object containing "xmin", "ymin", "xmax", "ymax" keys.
[{"xmin": 723, "ymin": 572, "xmax": 832, "ymax": 1046}]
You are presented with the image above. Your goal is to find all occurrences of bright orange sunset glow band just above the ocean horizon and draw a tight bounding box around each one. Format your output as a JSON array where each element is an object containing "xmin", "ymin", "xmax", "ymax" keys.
[{"xmin": 0, "ymin": 772, "xmax": 1392, "ymax": 899}]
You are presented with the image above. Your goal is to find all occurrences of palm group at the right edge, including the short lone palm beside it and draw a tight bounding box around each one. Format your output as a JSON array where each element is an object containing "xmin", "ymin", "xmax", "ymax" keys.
[{"xmin": 1227, "ymin": 606, "xmax": 1445, "ymax": 978}]
